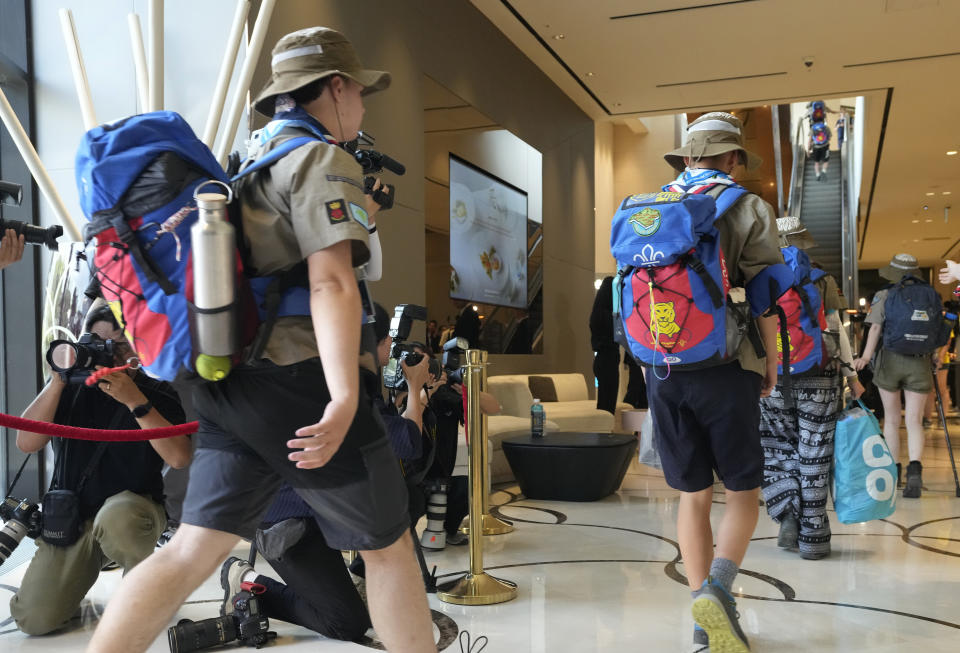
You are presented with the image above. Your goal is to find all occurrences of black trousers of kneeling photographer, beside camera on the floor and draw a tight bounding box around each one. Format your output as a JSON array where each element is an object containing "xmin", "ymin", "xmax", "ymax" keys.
[{"xmin": 257, "ymin": 519, "xmax": 371, "ymax": 641}]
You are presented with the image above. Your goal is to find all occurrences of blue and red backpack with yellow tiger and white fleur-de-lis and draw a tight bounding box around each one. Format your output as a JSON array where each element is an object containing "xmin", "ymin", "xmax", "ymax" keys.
[{"xmin": 610, "ymin": 183, "xmax": 789, "ymax": 369}]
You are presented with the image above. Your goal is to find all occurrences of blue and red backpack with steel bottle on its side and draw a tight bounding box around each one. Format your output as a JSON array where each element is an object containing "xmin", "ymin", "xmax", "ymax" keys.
[{"xmin": 76, "ymin": 111, "xmax": 317, "ymax": 381}]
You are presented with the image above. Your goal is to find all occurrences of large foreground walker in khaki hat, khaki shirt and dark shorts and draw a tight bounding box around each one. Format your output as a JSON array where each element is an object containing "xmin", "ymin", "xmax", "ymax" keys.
[{"xmin": 89, "ymin": 27, "xmax": 436, "ymax": 653}]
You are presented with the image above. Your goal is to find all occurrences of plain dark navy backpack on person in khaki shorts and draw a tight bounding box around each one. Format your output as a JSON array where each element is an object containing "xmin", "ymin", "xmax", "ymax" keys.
[{"xmin": 883, "ymin": 275, "xmax": 945, "ymax": 356}]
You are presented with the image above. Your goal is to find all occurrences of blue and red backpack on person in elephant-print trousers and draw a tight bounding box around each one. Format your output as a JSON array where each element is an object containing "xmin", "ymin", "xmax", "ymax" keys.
[{"xmin": 777, "ymin": 246, "xmax": 829, "ymax": 375}]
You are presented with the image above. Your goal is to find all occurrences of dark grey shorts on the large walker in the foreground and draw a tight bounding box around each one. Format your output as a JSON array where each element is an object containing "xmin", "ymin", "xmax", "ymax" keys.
[{"xmin": 182, "ymin": 359, "xmax": 410, "ymax": 551}]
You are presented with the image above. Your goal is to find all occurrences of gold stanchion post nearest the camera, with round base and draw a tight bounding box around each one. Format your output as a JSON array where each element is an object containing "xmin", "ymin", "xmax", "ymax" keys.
[{"xmin": 437, "ymin": 349, "xmax": 517, "ymax": 605}]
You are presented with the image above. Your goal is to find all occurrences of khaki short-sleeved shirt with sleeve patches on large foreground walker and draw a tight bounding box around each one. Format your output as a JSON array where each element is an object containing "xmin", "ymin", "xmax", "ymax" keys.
[{"xmin": 238, "ymin": 127, "xmax": 370, "ymax": 365}]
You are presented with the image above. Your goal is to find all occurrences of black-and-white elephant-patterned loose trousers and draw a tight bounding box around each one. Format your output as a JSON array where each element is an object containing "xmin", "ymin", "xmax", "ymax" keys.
[{"xmin": 760, "ymin": 376, "xmax": 842, "ymax": 553}]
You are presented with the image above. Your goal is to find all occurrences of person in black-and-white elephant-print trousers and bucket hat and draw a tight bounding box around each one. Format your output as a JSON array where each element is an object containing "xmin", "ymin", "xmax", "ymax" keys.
[{"xmin": 760, "ymin": 216, "xmax": 863, "ymax": 560}]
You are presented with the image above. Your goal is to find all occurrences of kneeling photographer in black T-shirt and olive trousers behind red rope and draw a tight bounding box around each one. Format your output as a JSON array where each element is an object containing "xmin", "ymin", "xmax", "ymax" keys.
[{"xmin": 10, "ymin": 303, "xmax": 191, "ymax": 635}]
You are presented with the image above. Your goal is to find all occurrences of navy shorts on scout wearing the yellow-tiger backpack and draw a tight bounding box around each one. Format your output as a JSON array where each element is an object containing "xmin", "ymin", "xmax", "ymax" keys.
[{"xmin": 647, "ymin": 363, "xmax": 763, "ymax": 492}]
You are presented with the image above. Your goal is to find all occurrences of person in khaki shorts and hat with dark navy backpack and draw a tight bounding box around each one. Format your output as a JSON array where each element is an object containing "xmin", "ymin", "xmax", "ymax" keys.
[{"xmin": 853, "ymin": 254, "xmax": 933, "ymax": 499}]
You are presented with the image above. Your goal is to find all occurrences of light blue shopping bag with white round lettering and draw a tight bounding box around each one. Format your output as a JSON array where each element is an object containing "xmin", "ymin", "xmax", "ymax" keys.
[{"xmin": 833, "ymin": 399, "xmax": 897, "ymax": 524}]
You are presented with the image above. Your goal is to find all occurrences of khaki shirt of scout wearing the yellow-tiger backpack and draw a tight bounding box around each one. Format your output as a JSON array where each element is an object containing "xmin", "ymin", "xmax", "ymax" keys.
[{"xmin": 716, "ymin": 193, "xmax": 783, "ymax": 376}]
